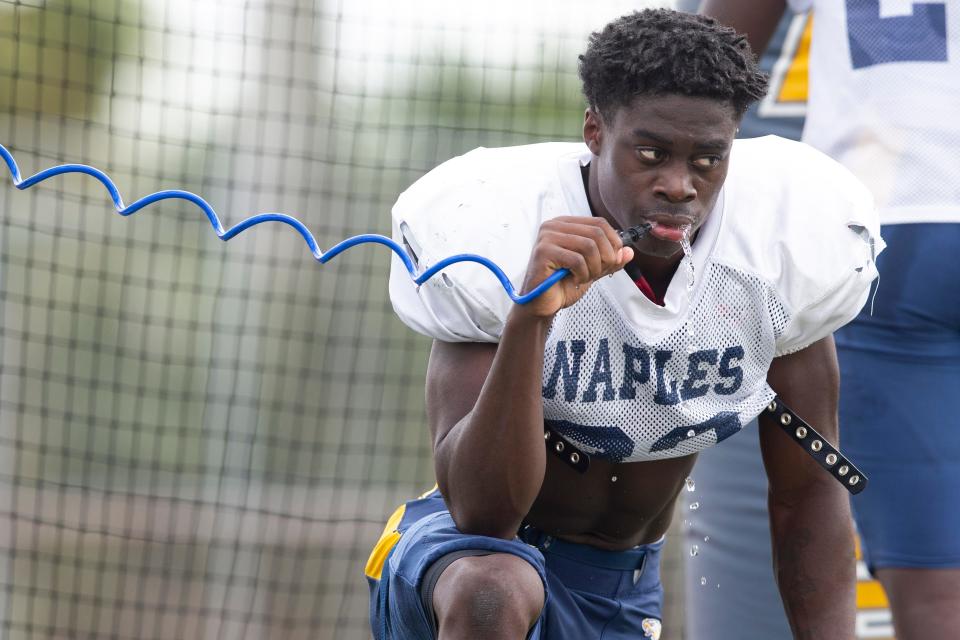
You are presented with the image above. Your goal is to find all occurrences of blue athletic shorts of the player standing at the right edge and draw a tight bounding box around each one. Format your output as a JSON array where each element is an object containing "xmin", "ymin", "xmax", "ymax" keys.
[{"xmin": 836, "ymin": 223, "xmax": 960, "ymax": 568}]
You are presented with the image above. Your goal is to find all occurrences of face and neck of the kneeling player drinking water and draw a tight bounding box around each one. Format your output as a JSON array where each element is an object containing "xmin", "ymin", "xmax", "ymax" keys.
[{"xmin": 583, "ymin": 95, "xmax": 739, "ymax": 297}]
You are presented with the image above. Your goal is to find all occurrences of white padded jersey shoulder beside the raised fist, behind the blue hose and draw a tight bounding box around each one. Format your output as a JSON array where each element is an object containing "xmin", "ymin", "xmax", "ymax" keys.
[{"xmin": 390, "ymin": 143, "xmax": 583, "ymax": 342}]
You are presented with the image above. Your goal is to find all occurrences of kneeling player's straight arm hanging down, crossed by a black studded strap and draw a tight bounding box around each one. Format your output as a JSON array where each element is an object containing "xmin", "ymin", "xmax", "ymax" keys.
[{"xmin": 760, "ymin": 337, "xmax": 856, "ymax": 640}]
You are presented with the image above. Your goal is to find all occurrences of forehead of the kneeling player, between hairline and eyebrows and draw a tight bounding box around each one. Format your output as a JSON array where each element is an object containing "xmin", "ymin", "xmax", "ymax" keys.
[{"xmin": 606, "ymin": 94, "xmax": 740, "ymax": 143}]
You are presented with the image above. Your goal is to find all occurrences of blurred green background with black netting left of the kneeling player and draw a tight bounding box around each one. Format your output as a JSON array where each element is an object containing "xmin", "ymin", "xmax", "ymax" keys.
[{"xmin": 0, "ymin": 0, "xmax": 683, "ymax": 639}]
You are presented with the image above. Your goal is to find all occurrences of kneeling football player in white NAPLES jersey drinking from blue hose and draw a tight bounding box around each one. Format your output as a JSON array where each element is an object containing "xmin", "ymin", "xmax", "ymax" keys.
[{"xmin": 366, "ymin": 10, "xmax": 882, "ymax": 640}]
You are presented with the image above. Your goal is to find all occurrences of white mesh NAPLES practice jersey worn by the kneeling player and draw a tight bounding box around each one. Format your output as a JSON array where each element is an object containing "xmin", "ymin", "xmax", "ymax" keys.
[{"xmin": 390, "ymin": 136, "xmax": 883, "ymax": 461}]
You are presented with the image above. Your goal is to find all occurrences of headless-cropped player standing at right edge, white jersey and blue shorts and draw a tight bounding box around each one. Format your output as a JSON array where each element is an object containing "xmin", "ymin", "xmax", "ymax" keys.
[{"xmin": 703, "ymin": 0, "xmax": 960, "ymax": 640}]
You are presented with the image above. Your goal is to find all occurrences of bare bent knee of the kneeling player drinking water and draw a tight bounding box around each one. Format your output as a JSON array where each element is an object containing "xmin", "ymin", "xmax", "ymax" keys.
[{"xmin": 433, "ymin": 553, "xmax": 544, "ymax": 638}]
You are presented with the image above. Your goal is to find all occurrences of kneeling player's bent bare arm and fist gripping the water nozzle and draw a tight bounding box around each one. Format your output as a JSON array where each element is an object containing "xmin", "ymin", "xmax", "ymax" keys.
[{"xmin": 427, "ymin": 217, "xmax": 633, "ymax": 538}]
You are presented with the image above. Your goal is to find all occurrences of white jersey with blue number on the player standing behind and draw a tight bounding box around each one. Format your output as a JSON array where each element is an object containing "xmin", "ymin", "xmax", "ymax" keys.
[{"xmin": 790, "ymin": 0, "xmax": 960, "ymax": 224}]
